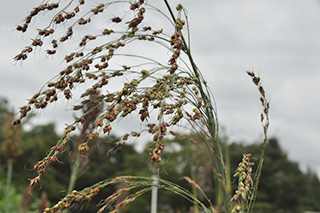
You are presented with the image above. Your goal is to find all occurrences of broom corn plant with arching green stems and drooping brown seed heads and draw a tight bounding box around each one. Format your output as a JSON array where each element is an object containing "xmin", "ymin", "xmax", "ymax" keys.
[{"xmin": 13, "ymin": 0, "xmax": 269, "ymax": 212}]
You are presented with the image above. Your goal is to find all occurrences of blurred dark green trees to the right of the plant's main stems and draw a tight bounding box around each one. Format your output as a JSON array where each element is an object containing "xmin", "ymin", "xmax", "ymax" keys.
[{"xmin": 229, "ymin": 139, "xmax": 319, "ymax": 212}]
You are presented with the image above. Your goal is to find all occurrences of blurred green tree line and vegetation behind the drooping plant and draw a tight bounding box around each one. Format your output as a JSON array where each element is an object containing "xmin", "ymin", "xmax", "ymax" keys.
[{"xmin": 0, "ymin": 98, "xmax": 320, "ymax": 213}]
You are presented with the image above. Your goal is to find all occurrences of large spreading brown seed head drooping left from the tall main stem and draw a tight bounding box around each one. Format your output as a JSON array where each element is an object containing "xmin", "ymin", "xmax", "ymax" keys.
[{"xmin": 15, "ymin": 0, "xmax": 208, "ymax": 196}]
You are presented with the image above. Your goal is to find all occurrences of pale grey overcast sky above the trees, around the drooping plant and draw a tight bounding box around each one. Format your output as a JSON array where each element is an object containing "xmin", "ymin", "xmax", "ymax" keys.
[{"xmin": 0, "ymin": 0, "xmax": 320, "ymax": 176}]
